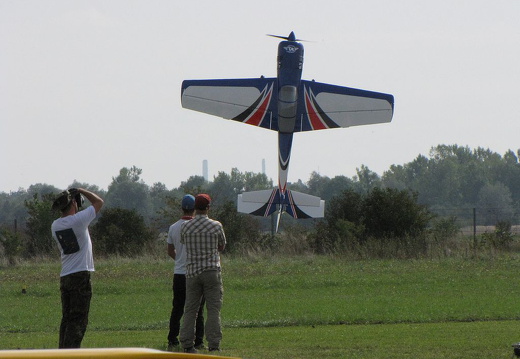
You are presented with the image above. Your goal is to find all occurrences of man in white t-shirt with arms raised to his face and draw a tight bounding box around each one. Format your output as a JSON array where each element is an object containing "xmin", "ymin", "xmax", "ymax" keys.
[{"xmin": 51, "ymin": 188, "xmax": 104, "ymax": 348}]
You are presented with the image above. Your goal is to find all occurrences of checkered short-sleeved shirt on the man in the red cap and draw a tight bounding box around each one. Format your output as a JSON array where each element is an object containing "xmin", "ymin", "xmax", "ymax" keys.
[{"xmin": 181, "ymin": 214, "xmax": 226, "ymax": 278}]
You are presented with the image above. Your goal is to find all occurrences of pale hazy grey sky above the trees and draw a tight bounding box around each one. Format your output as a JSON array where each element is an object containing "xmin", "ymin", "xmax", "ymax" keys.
[{"xmin": 0, "ymin": 0, "xmax": 520, "ymax": 193}]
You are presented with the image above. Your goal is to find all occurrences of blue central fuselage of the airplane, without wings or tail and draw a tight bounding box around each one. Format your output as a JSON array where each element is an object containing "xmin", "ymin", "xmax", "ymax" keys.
[{"xmin": 277, "ymin": 40, "xmax": 304, "ymax": 195}]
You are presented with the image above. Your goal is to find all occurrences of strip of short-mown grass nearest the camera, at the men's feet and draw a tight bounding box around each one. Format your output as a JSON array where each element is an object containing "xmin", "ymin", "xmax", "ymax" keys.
[{"xmin": 0, "ymin": 321, "xmax": 520, "ymax": 359}]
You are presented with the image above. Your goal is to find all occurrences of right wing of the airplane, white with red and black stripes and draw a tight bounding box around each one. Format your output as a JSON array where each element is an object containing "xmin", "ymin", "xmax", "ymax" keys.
[{"xmin": 295, "ymin": 80, "xmax": 394, "ymax": 132}]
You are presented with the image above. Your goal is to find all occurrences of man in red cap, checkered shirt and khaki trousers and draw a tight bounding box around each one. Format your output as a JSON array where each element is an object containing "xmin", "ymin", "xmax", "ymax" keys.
[{"xmin": 180, "ymin": 194, "xmax": 226, "ymax": 353}]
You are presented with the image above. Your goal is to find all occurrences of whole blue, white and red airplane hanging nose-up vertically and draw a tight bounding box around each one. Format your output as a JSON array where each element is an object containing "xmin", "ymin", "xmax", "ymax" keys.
[{"xmin": 181, "ymin": 32, "xmax": 394, "ymax": 230}]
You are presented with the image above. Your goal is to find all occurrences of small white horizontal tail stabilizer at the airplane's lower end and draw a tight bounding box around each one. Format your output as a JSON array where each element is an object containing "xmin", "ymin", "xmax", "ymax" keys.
[{"xmin": 237, "ymin": 188, "xmax": 325, "ymax": 218}]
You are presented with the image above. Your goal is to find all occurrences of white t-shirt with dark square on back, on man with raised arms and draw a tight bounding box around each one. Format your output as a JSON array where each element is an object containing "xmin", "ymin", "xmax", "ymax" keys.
[{"xmin": 51, "ymin": 206, "xmax": 96, "ymax": 277}]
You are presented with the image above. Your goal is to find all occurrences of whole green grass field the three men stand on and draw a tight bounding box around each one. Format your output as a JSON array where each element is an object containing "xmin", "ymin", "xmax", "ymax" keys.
[{"xmin": 0, "ymin": 256, "xmax": 520, "ymax": 359}]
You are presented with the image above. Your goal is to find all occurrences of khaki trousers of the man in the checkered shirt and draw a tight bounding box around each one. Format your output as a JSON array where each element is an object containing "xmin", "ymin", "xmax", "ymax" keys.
[{"xmin": 180, "ymin": 269, "xmax": 223, "ymax": 348}]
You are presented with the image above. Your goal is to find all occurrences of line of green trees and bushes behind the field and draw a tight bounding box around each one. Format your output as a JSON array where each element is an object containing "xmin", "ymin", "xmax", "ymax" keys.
[{"xmin": 0, "ymin": 145, "xmax": 520, "ymax": 262}]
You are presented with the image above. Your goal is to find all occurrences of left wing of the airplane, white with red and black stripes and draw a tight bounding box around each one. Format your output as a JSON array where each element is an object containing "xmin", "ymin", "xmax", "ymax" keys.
[{"xmin": 181, "ymin": 77, "xmax": 278, "ymax": 131}]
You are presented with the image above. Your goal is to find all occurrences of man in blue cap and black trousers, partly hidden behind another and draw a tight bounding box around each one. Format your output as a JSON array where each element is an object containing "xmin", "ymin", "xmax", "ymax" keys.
[{"xmin": 167, "ymin": 194, "xmax": 204, "ymax": 351}]
